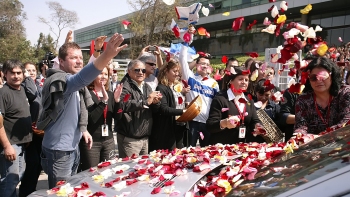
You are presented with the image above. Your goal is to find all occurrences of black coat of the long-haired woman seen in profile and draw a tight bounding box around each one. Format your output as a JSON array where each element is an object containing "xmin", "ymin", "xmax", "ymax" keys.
[{"xmin": 149, "ymin": 84, "xmax": 183, "ymax": 151}]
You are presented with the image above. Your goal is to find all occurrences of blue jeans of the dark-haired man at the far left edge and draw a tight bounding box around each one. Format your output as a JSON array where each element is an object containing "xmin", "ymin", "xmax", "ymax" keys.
[{"xmin": 0, "ymin": 144, "xmax": 26, "ymax": 197}]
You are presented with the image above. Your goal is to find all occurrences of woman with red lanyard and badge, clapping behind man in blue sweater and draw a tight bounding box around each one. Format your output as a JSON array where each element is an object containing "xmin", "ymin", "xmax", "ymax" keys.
[{"xmin": 79, "ymin": 67, "xmax": 122, "ymax": 170}]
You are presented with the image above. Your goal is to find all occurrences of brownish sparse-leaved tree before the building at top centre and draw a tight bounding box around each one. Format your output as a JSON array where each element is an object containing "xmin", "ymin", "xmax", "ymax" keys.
[{"xmin": 128, "ymin": 0, "xmax": 185, "ymax": 58}]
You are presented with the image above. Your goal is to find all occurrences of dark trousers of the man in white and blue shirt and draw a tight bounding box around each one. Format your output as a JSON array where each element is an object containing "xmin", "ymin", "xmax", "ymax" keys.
[{"xmin": 190, "ymin": 121, "xmax": 210, "ymax": 147}]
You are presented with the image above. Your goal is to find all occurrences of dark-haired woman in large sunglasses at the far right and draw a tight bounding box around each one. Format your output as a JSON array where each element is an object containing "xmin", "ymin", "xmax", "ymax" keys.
[{"xmin": 294, "ymin": 57, "xmax": 350, "ymax": 134}]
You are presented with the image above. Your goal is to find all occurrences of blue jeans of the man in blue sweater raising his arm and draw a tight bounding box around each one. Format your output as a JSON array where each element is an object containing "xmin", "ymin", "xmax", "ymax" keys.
[{"xmin": 40, "ymin": 147, "xmax": 80, "ymax": 189}]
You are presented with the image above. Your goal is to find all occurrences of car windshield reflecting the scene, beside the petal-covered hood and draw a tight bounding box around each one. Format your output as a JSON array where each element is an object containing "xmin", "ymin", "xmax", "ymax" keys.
[{"xmin": 227, "ymin": 126, "xmax": 350, "ymax": 196}]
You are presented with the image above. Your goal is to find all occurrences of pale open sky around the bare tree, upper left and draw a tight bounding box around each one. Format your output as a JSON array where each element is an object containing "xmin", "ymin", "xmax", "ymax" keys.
[{"xmin": 20, "ymin": 0, "xmax": 133, "ymax": 45}]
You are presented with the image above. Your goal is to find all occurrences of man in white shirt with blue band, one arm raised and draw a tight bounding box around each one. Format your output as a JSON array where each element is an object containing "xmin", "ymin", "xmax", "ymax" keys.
[{"xmin": 179, "ymin": 46, "xmax": 219, "ymax": 147}]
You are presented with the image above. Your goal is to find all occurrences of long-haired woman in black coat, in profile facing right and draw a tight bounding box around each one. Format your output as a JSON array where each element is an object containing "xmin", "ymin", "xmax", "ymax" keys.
[{"xmin": 149, "ymin": 59, "xmax": 190, "ymax": 151}]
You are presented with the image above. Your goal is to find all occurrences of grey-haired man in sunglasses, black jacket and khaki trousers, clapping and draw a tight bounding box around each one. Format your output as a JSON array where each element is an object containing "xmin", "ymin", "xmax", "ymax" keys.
[{"xmin": 115, "ymin": 60, "xmax": 161, "ymax": 158}]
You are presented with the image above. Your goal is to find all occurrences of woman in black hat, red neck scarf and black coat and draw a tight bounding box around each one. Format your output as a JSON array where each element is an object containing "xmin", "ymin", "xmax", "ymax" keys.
[{"xmin": 206, "ymin": 66, "xmax": 264, "ymax": 144}]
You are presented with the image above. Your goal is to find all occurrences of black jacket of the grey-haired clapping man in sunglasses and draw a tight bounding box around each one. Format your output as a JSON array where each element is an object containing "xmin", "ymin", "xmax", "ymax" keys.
[{"xmin": 115, "ymin": 74, "xmax": 160, "ymax": 139}]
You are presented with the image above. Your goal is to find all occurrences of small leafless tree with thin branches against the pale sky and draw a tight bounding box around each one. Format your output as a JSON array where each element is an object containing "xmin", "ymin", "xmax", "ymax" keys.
[{"xmin": 39, "ymin": 1, "xmax": 79, "ymax": 49}]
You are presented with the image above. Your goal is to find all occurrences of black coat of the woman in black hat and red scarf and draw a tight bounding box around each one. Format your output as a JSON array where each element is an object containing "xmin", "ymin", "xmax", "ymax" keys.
[{"xmin": 206, "ymin": 91, "xmax": 264, "ymax": 144}]
